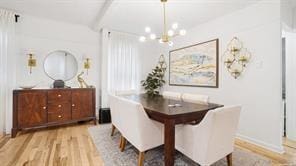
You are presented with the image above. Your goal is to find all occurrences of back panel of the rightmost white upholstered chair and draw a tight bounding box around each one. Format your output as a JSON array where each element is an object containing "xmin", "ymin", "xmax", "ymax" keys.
[{"xmin": 195, "ymin": 106, "xmax": 241, "ymax": 163}]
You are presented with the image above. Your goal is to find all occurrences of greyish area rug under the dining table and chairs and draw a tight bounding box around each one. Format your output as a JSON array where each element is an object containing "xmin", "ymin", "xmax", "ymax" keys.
[{"xmin": 88, "ymin": 124, "xmax": 271, "ymax": 166}]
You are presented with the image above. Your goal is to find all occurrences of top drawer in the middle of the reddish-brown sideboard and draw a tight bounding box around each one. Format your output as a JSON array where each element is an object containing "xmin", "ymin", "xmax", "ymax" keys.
[{"xmin": 47, "ymin": 90, "xmax": 71, "ymax": 103}]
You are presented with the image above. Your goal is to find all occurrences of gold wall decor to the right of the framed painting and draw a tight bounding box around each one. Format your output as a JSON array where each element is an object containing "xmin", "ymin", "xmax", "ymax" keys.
[{"xmin": 223, "ymin": 37, "xmax": 251, "ymax": 79}]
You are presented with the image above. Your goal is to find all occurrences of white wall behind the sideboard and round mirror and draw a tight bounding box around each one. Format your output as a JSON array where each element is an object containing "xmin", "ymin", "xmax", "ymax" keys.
[{"xmin": 6, "ymin": 14, "xmax": 100, "ymax": 132}]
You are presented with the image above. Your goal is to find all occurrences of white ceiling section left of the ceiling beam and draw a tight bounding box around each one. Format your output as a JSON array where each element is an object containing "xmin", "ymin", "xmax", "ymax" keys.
[{"xmin": 0, "ymin": 0, "xmax": 105, "ymax": 26}]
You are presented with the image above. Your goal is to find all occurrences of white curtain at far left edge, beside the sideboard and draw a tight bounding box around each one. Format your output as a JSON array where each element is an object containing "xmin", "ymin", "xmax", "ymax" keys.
[{"xmin": 0, "ymin": 9, "xmax": 16, "ymax": 134}]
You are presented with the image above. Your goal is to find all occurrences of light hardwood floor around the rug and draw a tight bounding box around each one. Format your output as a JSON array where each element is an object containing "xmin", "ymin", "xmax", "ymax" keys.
[{"xmin": 0, "ymin": 123, "xmax": 296, "ymax": 166}]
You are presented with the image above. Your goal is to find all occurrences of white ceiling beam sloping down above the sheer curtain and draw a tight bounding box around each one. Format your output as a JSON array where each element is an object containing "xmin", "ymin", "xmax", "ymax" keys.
[{"xmin": 91, "ymin": 0, "xmax": 115, "ymax": 32}]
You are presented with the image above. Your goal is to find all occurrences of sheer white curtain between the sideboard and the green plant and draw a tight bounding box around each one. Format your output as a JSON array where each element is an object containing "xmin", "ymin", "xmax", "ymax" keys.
[{"xmin": 108, "ymin": 32, "xmax": 140, "ymax": 92}]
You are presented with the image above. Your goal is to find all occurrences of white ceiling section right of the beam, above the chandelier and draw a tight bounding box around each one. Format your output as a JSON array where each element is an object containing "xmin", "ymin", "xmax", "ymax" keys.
[{"xmin": 102, "ymin": 0, "xmax": 258, "ymax": 34}]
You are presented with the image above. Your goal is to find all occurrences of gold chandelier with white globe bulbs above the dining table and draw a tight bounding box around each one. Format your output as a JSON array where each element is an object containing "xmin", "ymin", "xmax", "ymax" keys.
[{"xmin": 139, "ymin": 0, "xmax": 186, "ymax": 46}]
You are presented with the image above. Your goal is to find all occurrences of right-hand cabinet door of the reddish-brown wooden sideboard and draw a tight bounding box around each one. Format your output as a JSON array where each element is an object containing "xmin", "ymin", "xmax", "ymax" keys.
[{"xmin": 72, "ymin": 89, "xmax": 94, "ymax": 120}]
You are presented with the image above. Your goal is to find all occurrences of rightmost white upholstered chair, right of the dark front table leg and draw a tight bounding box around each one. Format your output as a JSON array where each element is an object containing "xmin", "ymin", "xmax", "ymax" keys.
[{"xmin": 176, "ymin": 106, "xmax": 241, "ymax": 166}]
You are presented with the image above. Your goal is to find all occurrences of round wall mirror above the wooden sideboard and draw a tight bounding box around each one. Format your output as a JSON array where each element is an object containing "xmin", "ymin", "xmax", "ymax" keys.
[{"xmin": 44, "ymin": 51, "xmax": 78, "ymax": 81}]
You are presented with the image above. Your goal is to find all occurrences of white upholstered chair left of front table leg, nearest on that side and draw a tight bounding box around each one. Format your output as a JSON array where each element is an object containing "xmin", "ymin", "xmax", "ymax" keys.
[{"xmin": 118, "ymin": 98, "xmax": 164, "ymax": 166}]
